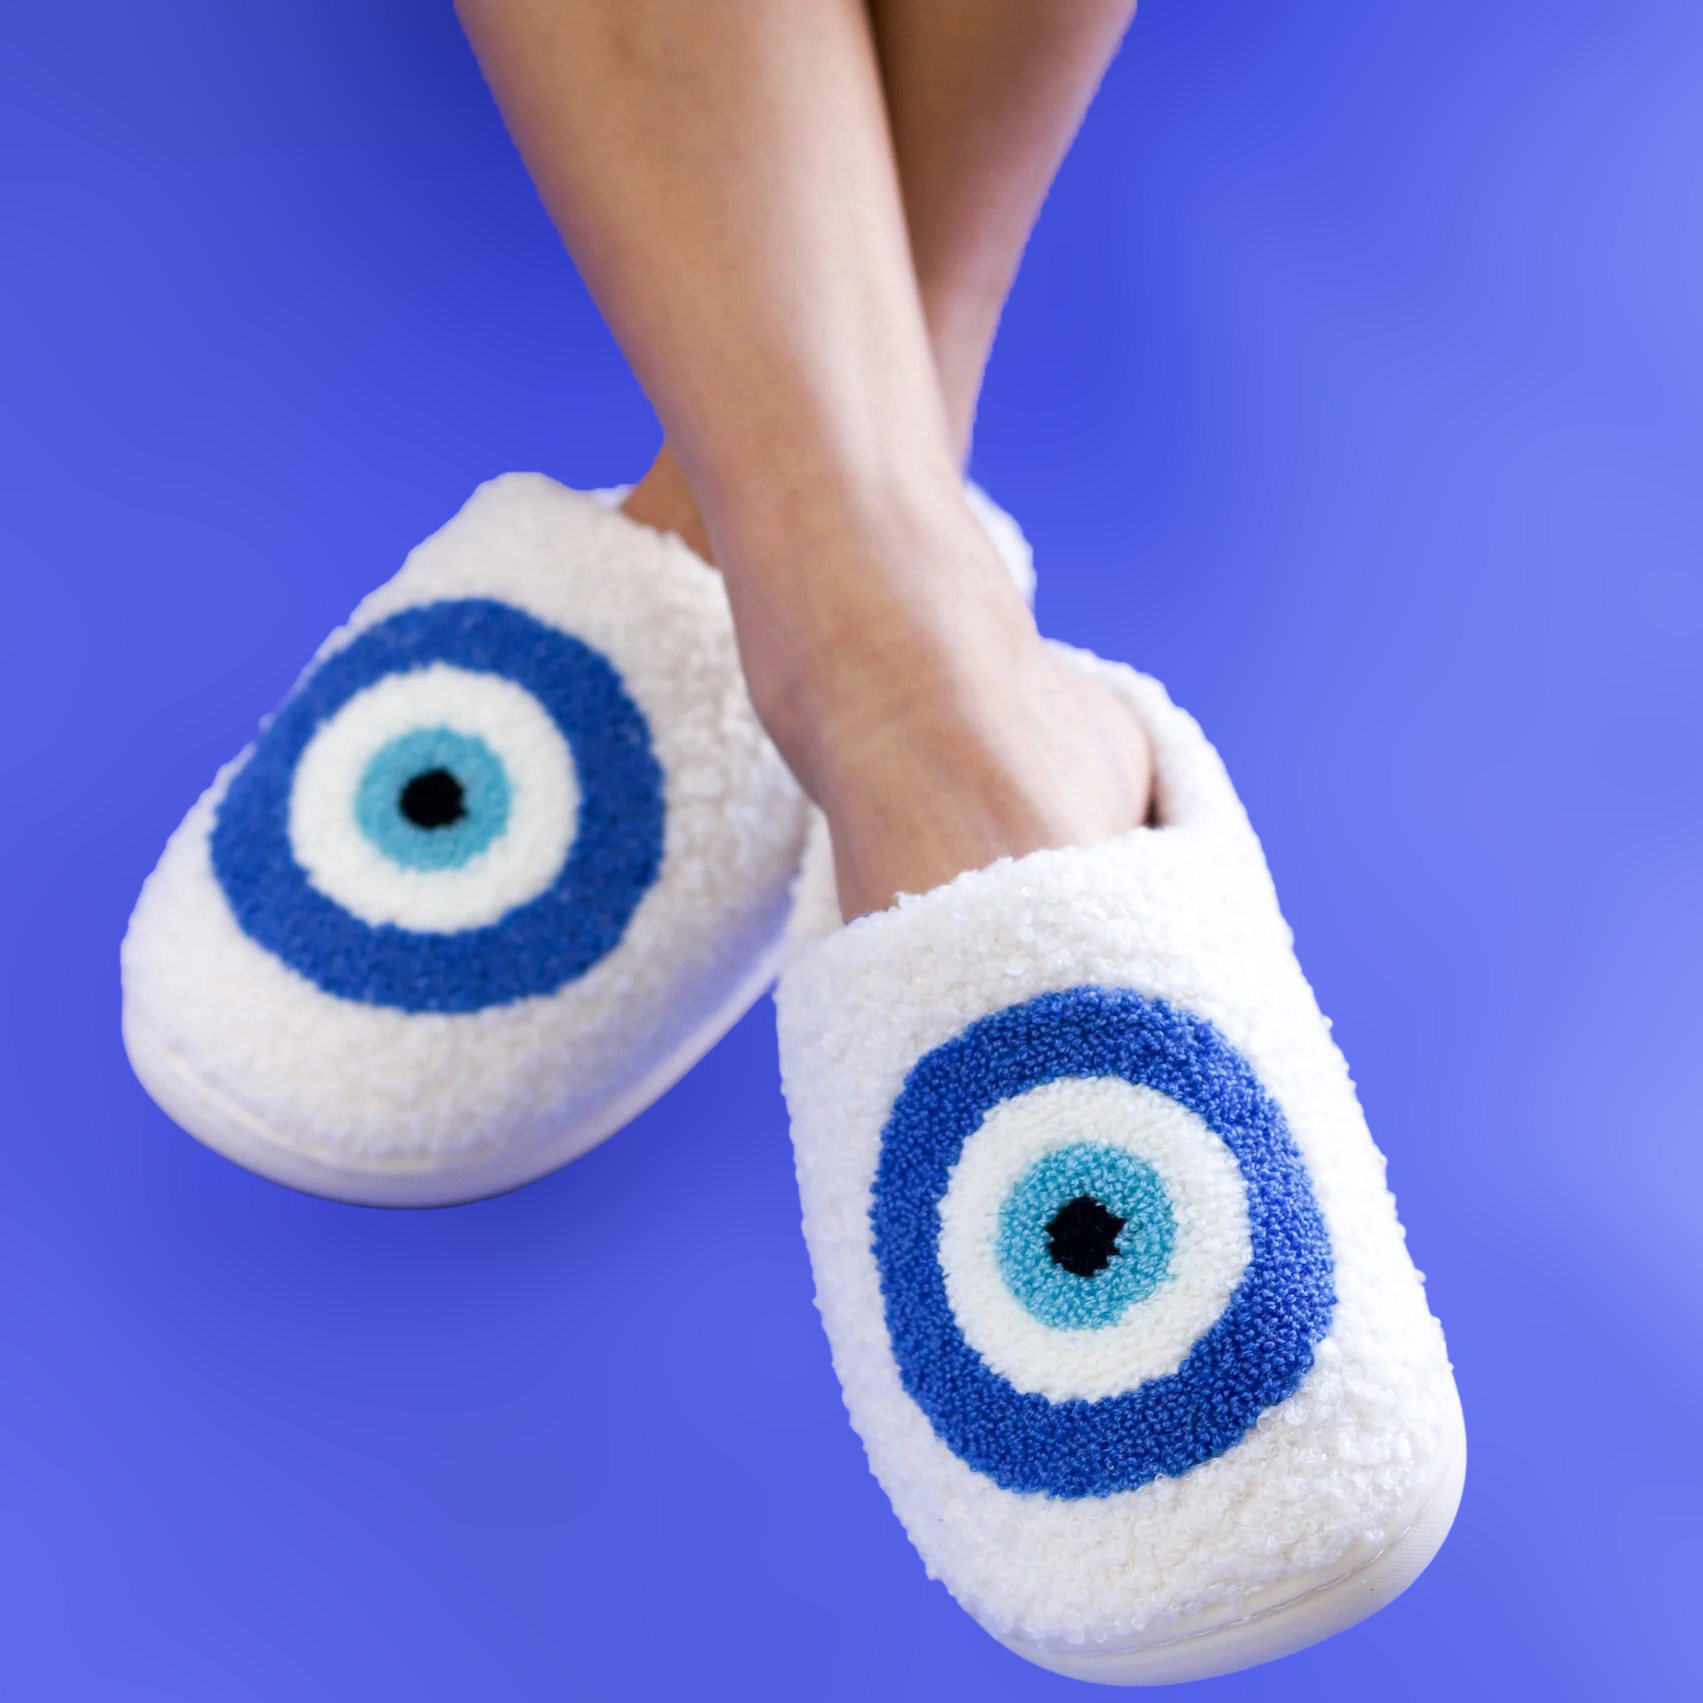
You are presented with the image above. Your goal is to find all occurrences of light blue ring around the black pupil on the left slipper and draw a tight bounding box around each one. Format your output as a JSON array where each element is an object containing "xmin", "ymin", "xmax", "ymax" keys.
[{"xmin": 354, "ymin": 727, "xmax": 513, "ymax": 870}]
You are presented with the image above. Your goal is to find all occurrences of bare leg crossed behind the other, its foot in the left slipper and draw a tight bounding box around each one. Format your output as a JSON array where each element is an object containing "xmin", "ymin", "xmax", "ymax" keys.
[{"xmin": 627, "ymin": 0, "xmax": 1136, "ymax": 555}]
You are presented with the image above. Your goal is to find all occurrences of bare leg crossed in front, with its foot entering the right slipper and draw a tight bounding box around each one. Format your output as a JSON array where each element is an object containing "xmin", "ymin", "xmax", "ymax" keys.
[{"xmin": 462, "ymin": 0, "xmax": 1148, "ymax": 916}]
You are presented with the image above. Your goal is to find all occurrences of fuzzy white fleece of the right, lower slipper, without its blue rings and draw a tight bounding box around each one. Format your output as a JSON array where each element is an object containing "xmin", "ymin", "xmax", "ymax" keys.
[{"xmin": 777, "ymin": 652, "xmax": 1459, "ymax": 1654}]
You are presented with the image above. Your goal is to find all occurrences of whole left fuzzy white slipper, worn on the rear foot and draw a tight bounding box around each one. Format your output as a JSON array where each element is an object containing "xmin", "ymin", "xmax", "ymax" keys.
[{"xmin": 123, "ymin": 473, "xmax": 1029, "ymax": 1206}]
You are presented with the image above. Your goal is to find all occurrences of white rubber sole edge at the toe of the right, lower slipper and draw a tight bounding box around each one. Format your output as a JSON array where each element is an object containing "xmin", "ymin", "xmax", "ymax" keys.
[{"xmin": 1000, "ymin": 1400, "xmax": 1466, "ymax": 1686}]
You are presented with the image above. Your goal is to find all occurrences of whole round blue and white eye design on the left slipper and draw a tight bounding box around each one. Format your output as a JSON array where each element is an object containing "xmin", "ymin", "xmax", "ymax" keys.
[{"xmin": 211, "ymin": 598, "xmax": 664, "ymax": 1012}]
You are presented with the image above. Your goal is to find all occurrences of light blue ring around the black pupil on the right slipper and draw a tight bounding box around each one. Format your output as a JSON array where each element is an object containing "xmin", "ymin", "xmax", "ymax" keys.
[{"xmin": 998, "ymin": 1143, "xmax": 1177, "ymax": 1330}]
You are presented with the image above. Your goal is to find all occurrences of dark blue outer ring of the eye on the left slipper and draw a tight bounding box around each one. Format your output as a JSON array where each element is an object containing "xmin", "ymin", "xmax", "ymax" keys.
[{"xmin": 211, "ymin": 598, "xmax": 664, "ymax": 1012}]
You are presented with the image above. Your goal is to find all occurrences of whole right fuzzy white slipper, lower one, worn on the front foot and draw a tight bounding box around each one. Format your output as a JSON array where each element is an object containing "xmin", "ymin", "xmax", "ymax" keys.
[{"xmin": 777, "ymin": 652, "xmax": 1466, "ymax": 1684}]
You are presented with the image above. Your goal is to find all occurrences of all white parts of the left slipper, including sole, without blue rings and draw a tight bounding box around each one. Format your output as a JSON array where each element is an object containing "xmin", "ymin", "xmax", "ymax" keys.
[{"xmin": 123, "ymin": 473, "xmax": 1034, "ymax": 1204}]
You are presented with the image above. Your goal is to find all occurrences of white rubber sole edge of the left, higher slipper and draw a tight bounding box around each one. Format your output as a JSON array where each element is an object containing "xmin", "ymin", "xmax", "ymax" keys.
[{"xmin": 123, "ymin": 943, "xmax": 782, "ymax": 1207}]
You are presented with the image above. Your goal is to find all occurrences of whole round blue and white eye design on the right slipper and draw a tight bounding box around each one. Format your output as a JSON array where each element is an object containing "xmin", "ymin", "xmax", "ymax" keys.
[{"xmin": 870, "ymin": 988, "xmax": 1335, "ymax": 1499}]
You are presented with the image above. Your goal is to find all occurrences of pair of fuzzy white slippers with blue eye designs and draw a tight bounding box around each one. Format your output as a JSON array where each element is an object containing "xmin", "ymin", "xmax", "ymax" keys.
[{"xmin": 123, "ymin": 475, "xmax": 1465, "ymax": 1684}]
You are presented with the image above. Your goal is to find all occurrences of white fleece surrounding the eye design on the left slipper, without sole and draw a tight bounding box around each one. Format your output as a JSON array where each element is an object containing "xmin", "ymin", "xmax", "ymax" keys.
[{"xmin": 123, "ymin": 473, "xmax": 806, "ymax": 1199}]
